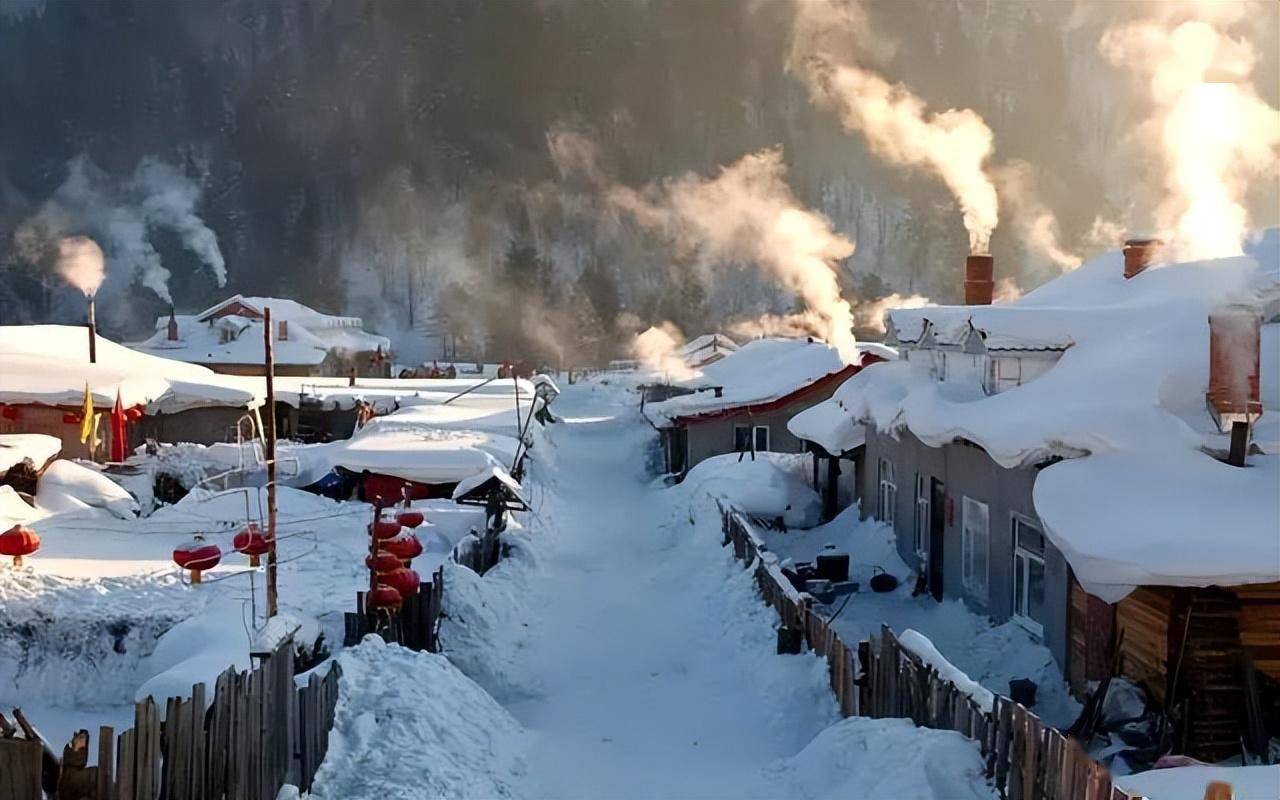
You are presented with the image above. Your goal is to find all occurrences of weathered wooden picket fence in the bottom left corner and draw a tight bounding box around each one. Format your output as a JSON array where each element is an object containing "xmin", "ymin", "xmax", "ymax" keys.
[{"xmin": 0, "ymin": 640, "xmax": 340, "ymax": 800}]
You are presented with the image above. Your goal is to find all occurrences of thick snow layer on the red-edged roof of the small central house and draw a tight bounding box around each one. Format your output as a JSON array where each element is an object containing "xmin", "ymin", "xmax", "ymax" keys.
[{"xmin": 645, "ymin": 339, "xmax": 849, "ymax": 422}]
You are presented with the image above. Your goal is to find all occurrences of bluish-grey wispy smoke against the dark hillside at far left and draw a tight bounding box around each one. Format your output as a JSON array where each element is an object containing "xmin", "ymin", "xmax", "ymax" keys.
[{"xmin": 14, "ymin": 156, "xmax": 227, "ymax": 302}]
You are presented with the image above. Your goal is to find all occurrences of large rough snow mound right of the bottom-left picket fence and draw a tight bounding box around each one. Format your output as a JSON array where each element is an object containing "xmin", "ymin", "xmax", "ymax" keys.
[{"xmin": 311, "ymin": 636, "xmax": 527, "ymax": 800}]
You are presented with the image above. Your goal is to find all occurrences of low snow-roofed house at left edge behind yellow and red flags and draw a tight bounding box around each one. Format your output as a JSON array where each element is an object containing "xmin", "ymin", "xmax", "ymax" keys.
[{"xmin": 0, "ymin": 325, "xmax": 262, "ymax": 458}]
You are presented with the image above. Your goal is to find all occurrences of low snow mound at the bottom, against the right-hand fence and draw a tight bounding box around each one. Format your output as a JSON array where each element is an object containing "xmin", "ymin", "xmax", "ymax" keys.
[{"xmin": 765, "ymin": 717, "xmax": 997, "ymax": 800}]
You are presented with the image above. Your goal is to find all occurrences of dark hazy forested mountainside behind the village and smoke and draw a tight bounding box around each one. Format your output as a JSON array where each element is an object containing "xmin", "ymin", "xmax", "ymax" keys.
[{"xmin": 0, "ymin": 0, "xmax": 1280, "ymax": 362}]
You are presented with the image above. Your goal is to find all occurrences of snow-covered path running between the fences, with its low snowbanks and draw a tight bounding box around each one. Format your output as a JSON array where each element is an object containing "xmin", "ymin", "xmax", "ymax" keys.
[{"xmin": 317, "ymin": 383, "xmax": 992, "ymax": 800}]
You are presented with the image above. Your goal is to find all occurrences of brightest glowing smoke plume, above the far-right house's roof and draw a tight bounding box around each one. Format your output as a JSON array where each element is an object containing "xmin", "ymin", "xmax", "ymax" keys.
[{"xmin": 1100, "ymin": 3, "xmax": 1280, "ymax": 260}]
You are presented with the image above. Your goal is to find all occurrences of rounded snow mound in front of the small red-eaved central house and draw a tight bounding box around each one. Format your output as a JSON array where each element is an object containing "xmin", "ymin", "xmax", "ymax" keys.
[{"xmin": 675, "ymin": 453, "xmax": 822, "ymax": 527}]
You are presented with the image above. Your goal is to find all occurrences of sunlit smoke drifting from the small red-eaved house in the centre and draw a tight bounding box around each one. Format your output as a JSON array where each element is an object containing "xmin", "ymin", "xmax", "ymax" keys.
[{"xmin": 607, "ymin": 150, "xmax": 858, "ymax": 362}]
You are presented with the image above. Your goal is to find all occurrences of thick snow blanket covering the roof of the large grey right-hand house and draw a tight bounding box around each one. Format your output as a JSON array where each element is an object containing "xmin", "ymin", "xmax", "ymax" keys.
[{"xmin": 808, "ymin": 230, "xmax": 1280, "ymax": 602}]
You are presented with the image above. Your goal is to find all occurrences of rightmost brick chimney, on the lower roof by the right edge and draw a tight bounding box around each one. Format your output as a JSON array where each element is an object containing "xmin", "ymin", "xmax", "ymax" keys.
[{"xmin": 1206, "ymin": 306, "xmax": 1262, "ymax": 433}]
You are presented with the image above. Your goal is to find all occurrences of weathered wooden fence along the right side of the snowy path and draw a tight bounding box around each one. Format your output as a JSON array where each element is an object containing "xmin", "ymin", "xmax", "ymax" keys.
[{"xmin": 721, "ymin": 506, "xmax": 1135, "ymax": 800}]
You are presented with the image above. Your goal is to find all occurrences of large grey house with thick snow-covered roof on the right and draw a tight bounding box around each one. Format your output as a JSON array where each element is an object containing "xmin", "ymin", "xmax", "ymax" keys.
[{"xmin": 814, "ymin": 236, "xmax": 1280, "ymax": 758}]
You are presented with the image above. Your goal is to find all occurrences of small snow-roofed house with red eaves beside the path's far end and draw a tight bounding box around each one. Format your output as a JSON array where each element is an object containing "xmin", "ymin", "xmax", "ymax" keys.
[{"xmin": 644, "ymin": 339, "xmax": 879, "ymax": 475}]
